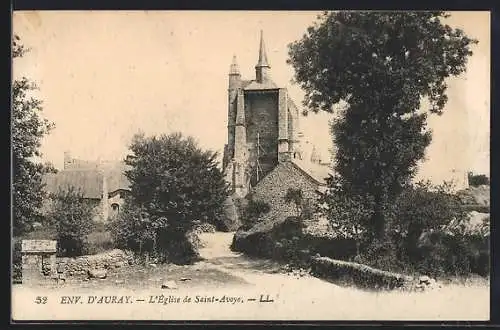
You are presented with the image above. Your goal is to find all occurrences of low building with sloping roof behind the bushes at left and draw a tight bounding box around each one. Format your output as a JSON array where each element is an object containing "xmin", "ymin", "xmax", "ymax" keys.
[{"xmin": 43, "ymin": 152, "xmax": 130, "ymax": 222}]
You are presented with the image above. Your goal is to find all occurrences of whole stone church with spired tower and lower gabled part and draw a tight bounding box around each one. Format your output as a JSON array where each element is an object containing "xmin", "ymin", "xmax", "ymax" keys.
[{"xmin": 223, "ymin": 31, "xmax": 331, "ymax": 224}]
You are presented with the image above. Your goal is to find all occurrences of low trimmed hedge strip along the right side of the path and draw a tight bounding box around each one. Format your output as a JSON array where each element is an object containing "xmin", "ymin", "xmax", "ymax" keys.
[{"xmin": 311, "ymin": 257, "xmax": 413, "ymax": 289}]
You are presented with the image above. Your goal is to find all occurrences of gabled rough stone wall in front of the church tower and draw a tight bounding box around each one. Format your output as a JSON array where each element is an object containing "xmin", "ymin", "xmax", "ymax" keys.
[{"xmin": 253, "ymin": 162, "xmax": 318, "ymax": 221}]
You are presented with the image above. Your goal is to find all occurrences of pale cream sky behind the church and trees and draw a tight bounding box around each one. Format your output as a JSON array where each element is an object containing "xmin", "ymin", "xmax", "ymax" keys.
[{"xmin": 13, "ymin": 11, "xmax": 490, "ymax": 180}]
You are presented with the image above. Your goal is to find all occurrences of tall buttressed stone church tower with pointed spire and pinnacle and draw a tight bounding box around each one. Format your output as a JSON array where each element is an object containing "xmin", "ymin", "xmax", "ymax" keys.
[{"xmin": 223, "ymin": 31, "xmax": 300, "ymax": 196}]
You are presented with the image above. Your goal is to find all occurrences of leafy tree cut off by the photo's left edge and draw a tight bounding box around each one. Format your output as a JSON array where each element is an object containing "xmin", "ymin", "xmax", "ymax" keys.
[{"xmin": 11, "ymin": 36, "xmax": 54, "ymax": 235}]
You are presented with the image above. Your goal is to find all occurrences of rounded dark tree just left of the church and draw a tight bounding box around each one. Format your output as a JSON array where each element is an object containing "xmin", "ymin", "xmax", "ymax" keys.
[{"xmin": 125, "ymin": 133, "xmax": 229, "ymax": 263}]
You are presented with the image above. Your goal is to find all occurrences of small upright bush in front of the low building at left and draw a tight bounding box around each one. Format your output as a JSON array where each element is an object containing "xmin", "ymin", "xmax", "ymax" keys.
[{"xmin": 49, "ymin": 187, "xmax": 94, "ymax": 257}]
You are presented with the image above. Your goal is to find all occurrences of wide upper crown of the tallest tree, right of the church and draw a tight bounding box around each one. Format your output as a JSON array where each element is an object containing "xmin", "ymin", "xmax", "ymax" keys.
[{"xmin": 288, "ymin": 11, "xmax": 477, "ymax": 114}]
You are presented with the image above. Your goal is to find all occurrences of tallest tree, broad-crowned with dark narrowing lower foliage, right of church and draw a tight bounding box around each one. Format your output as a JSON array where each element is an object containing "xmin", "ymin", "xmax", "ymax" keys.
[{"xmin": 289, "ymin": 11, "xmax": 477, "ymax": 241}]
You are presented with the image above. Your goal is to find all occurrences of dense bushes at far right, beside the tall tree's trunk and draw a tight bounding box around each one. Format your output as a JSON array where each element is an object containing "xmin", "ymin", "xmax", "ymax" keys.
[{"xmin": 356, "ymin": 182, "xmax": 489, "ymax": 276}]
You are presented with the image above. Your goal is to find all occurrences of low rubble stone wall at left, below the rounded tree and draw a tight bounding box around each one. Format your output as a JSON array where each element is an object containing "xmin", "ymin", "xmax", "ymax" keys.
[{"xmin": 56, "ymin": 249, "xmax": 133, "ymax": 276}]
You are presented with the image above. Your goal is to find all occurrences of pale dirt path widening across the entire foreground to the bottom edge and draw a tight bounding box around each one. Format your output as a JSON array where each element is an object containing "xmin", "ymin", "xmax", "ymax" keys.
[{"xmin": 13, "ymin": 233, "xmax": 489, "ymax": 320}]
